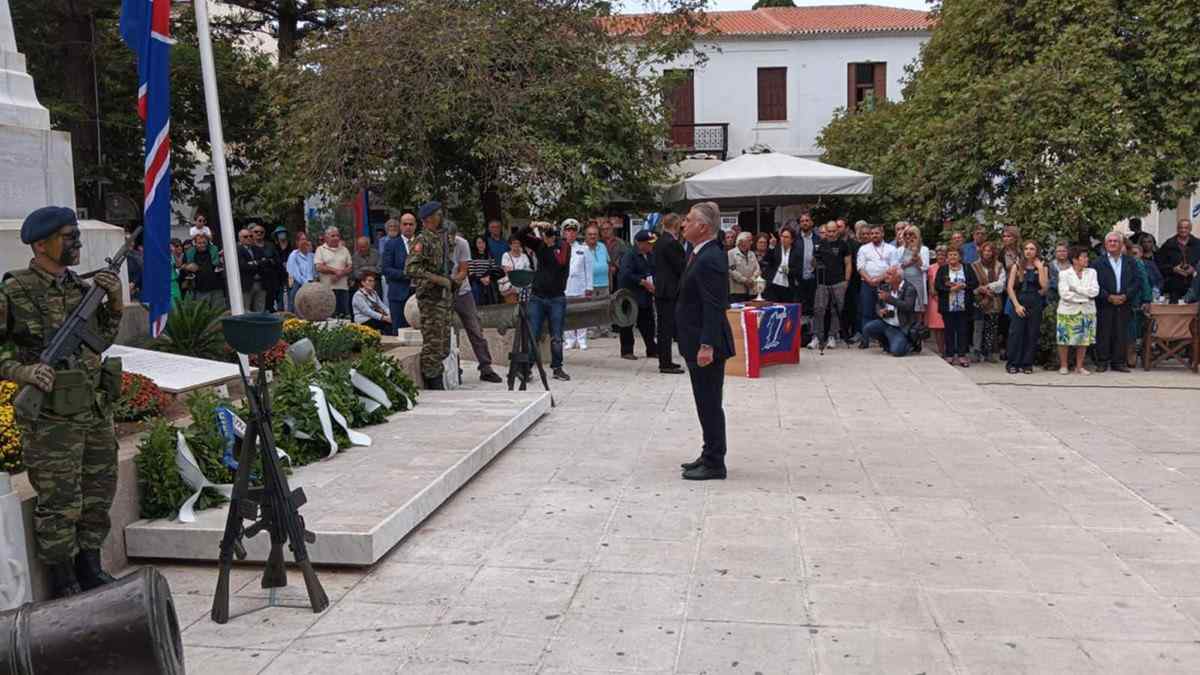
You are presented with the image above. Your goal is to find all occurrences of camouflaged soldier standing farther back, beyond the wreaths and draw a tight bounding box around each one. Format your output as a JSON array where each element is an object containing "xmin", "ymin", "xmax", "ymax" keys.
[{"xmin": 404, "ymin": 202, "xmax": 458, "ymax": 389}]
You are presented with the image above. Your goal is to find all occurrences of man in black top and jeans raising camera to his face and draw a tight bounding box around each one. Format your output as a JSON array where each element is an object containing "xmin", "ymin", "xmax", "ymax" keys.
[{"xmin": 522, "ymin": 222, "xmax": 571, "ymax": 382}]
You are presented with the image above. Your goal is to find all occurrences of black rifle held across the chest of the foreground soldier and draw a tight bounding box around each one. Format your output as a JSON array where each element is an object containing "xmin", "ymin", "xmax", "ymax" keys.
[{"xmin": 12, "ymin": 227, "xmax": 142, "ymax": 419}]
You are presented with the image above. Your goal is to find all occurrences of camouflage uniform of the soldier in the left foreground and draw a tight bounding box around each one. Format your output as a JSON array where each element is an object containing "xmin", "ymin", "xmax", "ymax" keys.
[{"xmin": 0, "ymin": 263, "xmax": 121, "ymax": 563}]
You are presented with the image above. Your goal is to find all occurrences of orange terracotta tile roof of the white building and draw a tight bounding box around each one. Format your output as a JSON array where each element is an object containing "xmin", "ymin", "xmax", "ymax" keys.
[{"xmin": 611, "ymin": 5, "xmax": 934, "ymax": 36}]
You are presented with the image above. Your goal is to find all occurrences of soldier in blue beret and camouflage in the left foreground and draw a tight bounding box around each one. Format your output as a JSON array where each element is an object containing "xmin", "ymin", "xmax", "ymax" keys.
[{"xmin": 0, "ymin": 207, "xmax": 124, "ymax": 597}]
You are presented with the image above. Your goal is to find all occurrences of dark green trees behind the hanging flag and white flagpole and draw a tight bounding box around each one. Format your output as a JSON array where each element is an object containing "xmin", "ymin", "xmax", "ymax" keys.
[{"xmin": 11, "ymin": 0, "xmax": 275, "ymax": 217}]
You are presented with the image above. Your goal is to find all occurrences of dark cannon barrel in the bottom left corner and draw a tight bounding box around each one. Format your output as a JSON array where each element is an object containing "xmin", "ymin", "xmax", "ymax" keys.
[{"xmin": 0, "ymin": 567, "xmax": 184, "ymax": 675}]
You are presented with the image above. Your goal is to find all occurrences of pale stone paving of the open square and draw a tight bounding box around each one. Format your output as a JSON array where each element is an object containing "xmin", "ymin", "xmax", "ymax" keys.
[{"xmin": 157, "ymin": 340, "xmax": 1200, "ymax": 675}]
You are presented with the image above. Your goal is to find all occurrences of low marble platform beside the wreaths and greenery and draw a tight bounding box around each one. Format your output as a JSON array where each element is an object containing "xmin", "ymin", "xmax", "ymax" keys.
[{"xmin": 125, "ymin": 389, "xmax": 550, "ymax": 566}]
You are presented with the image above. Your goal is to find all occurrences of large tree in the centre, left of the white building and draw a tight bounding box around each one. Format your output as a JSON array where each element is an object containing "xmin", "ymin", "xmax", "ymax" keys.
[{"xmin": 281, "ymin": 0, "xmax": 704, "ymax": 222}]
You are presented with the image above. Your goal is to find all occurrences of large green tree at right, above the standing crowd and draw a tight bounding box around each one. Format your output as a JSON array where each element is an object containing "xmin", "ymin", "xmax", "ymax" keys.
[{"xmin": 818, "ymin": 0, "xmax": 1200, "ymax": 240}]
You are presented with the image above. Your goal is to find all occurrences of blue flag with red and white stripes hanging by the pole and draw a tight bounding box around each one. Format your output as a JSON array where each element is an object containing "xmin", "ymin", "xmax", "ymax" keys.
[{"xmin": 121, "ymin": 0, "xmax": 174, "ymax": 338}]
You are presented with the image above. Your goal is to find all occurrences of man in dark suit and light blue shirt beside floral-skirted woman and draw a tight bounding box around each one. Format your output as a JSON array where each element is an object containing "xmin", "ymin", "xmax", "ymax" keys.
[{"xmin": 1092, "ymin": 232, "xmax": 1138, "ymax": 372}]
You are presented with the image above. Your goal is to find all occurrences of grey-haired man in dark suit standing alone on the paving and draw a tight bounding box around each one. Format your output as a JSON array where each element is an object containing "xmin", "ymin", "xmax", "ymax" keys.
[{"xmin": 676, "ymin": 202, "xmax": 733, "ymax": 480}]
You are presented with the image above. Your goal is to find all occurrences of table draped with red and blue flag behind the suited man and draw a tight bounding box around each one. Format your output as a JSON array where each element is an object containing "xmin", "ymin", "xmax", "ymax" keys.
[{"xmin": 725, "ymin": 303, "xmax": 800, "ymax": 377}]
